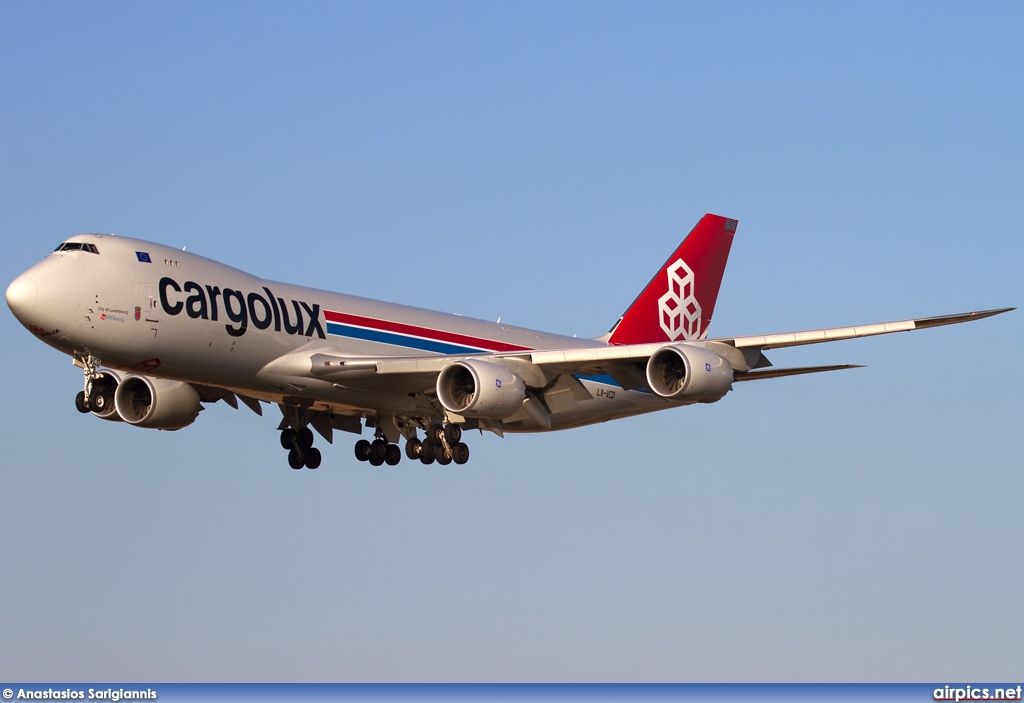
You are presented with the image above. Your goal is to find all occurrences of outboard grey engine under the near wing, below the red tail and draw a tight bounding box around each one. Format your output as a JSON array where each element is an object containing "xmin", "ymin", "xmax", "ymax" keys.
[{"xmin": 647, "ymin": 344, "xmax": 732, "ymax": 403}]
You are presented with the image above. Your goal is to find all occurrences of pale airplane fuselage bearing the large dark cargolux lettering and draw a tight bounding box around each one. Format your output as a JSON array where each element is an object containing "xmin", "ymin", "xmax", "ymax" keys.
[{"xmin": 9, "ymin": 234, "xmax": 667, "ymax": 432}]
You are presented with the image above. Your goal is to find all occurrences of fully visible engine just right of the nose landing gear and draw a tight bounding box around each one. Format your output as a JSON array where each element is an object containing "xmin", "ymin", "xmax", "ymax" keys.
[{"xmin": 114, "ymin": 376, "xmax": 203, "ymax": 430}]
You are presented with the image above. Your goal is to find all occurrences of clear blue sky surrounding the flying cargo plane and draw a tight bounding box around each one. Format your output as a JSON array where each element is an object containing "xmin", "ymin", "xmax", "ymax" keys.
[{"xmin": 0, "ymin": 2, "xmax": 1024, "ymax": 682}]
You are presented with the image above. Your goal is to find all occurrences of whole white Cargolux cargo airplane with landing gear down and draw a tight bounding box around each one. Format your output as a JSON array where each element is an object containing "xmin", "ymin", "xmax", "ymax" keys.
[{"xmin": 6, "ymin": 215, "xmax": 1013, "ymax": 469}]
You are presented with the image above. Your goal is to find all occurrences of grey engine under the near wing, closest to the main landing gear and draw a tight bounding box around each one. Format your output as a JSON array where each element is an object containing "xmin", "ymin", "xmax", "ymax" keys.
[{"xmin": 437, "ymin": 359, "xmax": 526, "ymax": 420}]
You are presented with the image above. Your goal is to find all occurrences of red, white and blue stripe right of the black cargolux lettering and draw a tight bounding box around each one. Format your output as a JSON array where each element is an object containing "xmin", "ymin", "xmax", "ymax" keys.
[{"xmin": 324, "ymin": 310, "xmax": 532, "ymax": 354}]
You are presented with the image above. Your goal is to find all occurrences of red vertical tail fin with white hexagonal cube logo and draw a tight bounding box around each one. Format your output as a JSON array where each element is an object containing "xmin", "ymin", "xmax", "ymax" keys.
[{"xmin": 608, "ymin": 215, "xmax": 736, "ymax": 344}]
